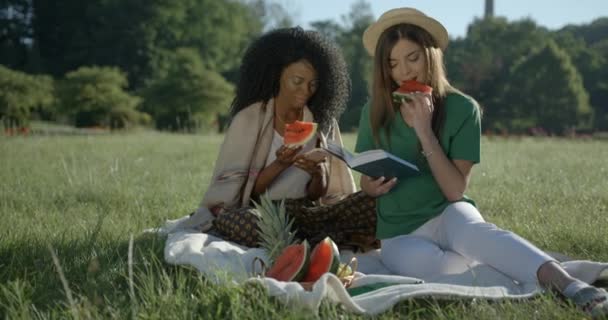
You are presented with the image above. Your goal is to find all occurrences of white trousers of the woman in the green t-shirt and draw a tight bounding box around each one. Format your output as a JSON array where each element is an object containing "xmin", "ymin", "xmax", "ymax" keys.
[{"xmin": 381, "ymin": 202, "xmax": 555, "ymax": 283}]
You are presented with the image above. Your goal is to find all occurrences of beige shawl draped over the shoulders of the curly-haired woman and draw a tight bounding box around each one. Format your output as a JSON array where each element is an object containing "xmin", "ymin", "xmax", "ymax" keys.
[{"xmin": 177, "ymin": 99, "xmax": 356, "ymax": 232}]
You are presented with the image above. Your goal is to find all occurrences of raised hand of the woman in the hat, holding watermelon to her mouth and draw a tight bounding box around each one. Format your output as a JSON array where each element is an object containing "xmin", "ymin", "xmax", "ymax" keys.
[{"xmin": 399, "ymin": 92, "xmax": 434, "ymax": 135}]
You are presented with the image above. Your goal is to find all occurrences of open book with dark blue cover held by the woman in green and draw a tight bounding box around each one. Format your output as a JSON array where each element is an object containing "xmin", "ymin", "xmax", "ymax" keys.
[{"xmin": 323, "ymin": 142, "xmax": 420, "ymax": 179}]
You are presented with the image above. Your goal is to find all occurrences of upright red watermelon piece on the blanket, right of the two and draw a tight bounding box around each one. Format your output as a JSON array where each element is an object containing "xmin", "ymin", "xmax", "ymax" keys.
[{"xmin": 302, "ymin": 237, "xmax": 340, "ymax": 282}]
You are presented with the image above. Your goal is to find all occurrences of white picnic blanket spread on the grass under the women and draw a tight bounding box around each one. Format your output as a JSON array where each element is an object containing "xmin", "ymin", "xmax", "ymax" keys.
[{"xmin": 160, "ymin": 221, "xmax": 608, "ymax": 315}]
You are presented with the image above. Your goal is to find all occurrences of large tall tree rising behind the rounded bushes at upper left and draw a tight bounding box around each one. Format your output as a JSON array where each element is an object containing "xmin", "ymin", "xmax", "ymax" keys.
[{"xmin": 31, "ymin": 0, "xmax": 262, "ymax": 89}]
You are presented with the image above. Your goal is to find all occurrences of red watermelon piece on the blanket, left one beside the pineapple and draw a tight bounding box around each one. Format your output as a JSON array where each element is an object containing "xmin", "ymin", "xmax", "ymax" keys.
[{"xmin": 266, "ymin": 240, "xmax": 310, "ymax": 281}]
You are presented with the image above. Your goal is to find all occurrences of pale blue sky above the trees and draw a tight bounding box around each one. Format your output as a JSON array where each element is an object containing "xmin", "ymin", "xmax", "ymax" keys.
[{"xmin": 284, "ymin": 0, "xmax": 608, "ymax": 38}]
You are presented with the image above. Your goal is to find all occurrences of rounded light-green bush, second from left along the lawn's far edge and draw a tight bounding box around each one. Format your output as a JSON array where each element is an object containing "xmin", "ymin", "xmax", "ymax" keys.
[{"xmin": 59, "ymin": 67, "xmax": 148, "ymax": 129}]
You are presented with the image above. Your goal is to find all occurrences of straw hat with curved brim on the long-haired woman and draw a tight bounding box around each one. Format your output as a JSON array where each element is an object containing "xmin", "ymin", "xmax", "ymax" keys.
[{"xmin": 363, "ymin": 8, "xmax": 448, "ymax": 56}]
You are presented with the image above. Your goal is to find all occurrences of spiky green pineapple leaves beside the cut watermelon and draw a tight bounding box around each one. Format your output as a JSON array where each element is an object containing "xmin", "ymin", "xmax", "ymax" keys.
[{"xmin": 254, "ymin": 194, "xmax": 295, "ymax": 265}]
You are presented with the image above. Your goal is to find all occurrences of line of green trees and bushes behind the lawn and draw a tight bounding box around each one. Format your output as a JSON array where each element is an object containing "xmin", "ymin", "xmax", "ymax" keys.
[{"xmin": 0, "ymin": 0, "xmax": 608, "ymax": 134}]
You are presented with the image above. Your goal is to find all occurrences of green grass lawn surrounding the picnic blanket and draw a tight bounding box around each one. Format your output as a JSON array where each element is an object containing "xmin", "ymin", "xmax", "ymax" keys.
[{"xmin": 0, "ymin": 132, "xmax": 608, "ymax": 319}]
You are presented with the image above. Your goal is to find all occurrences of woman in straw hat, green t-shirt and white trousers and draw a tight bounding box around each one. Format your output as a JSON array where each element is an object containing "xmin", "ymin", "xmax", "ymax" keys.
[{"xmin": 356, "ymin": 8, "xmax": 608, "ymax": 316}]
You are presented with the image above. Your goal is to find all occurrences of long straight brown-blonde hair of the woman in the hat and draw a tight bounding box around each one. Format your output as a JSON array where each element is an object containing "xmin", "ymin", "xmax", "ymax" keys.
[{"xmin": 370, "ymin": 24, "xmax": 457, "ymax": 146}]
